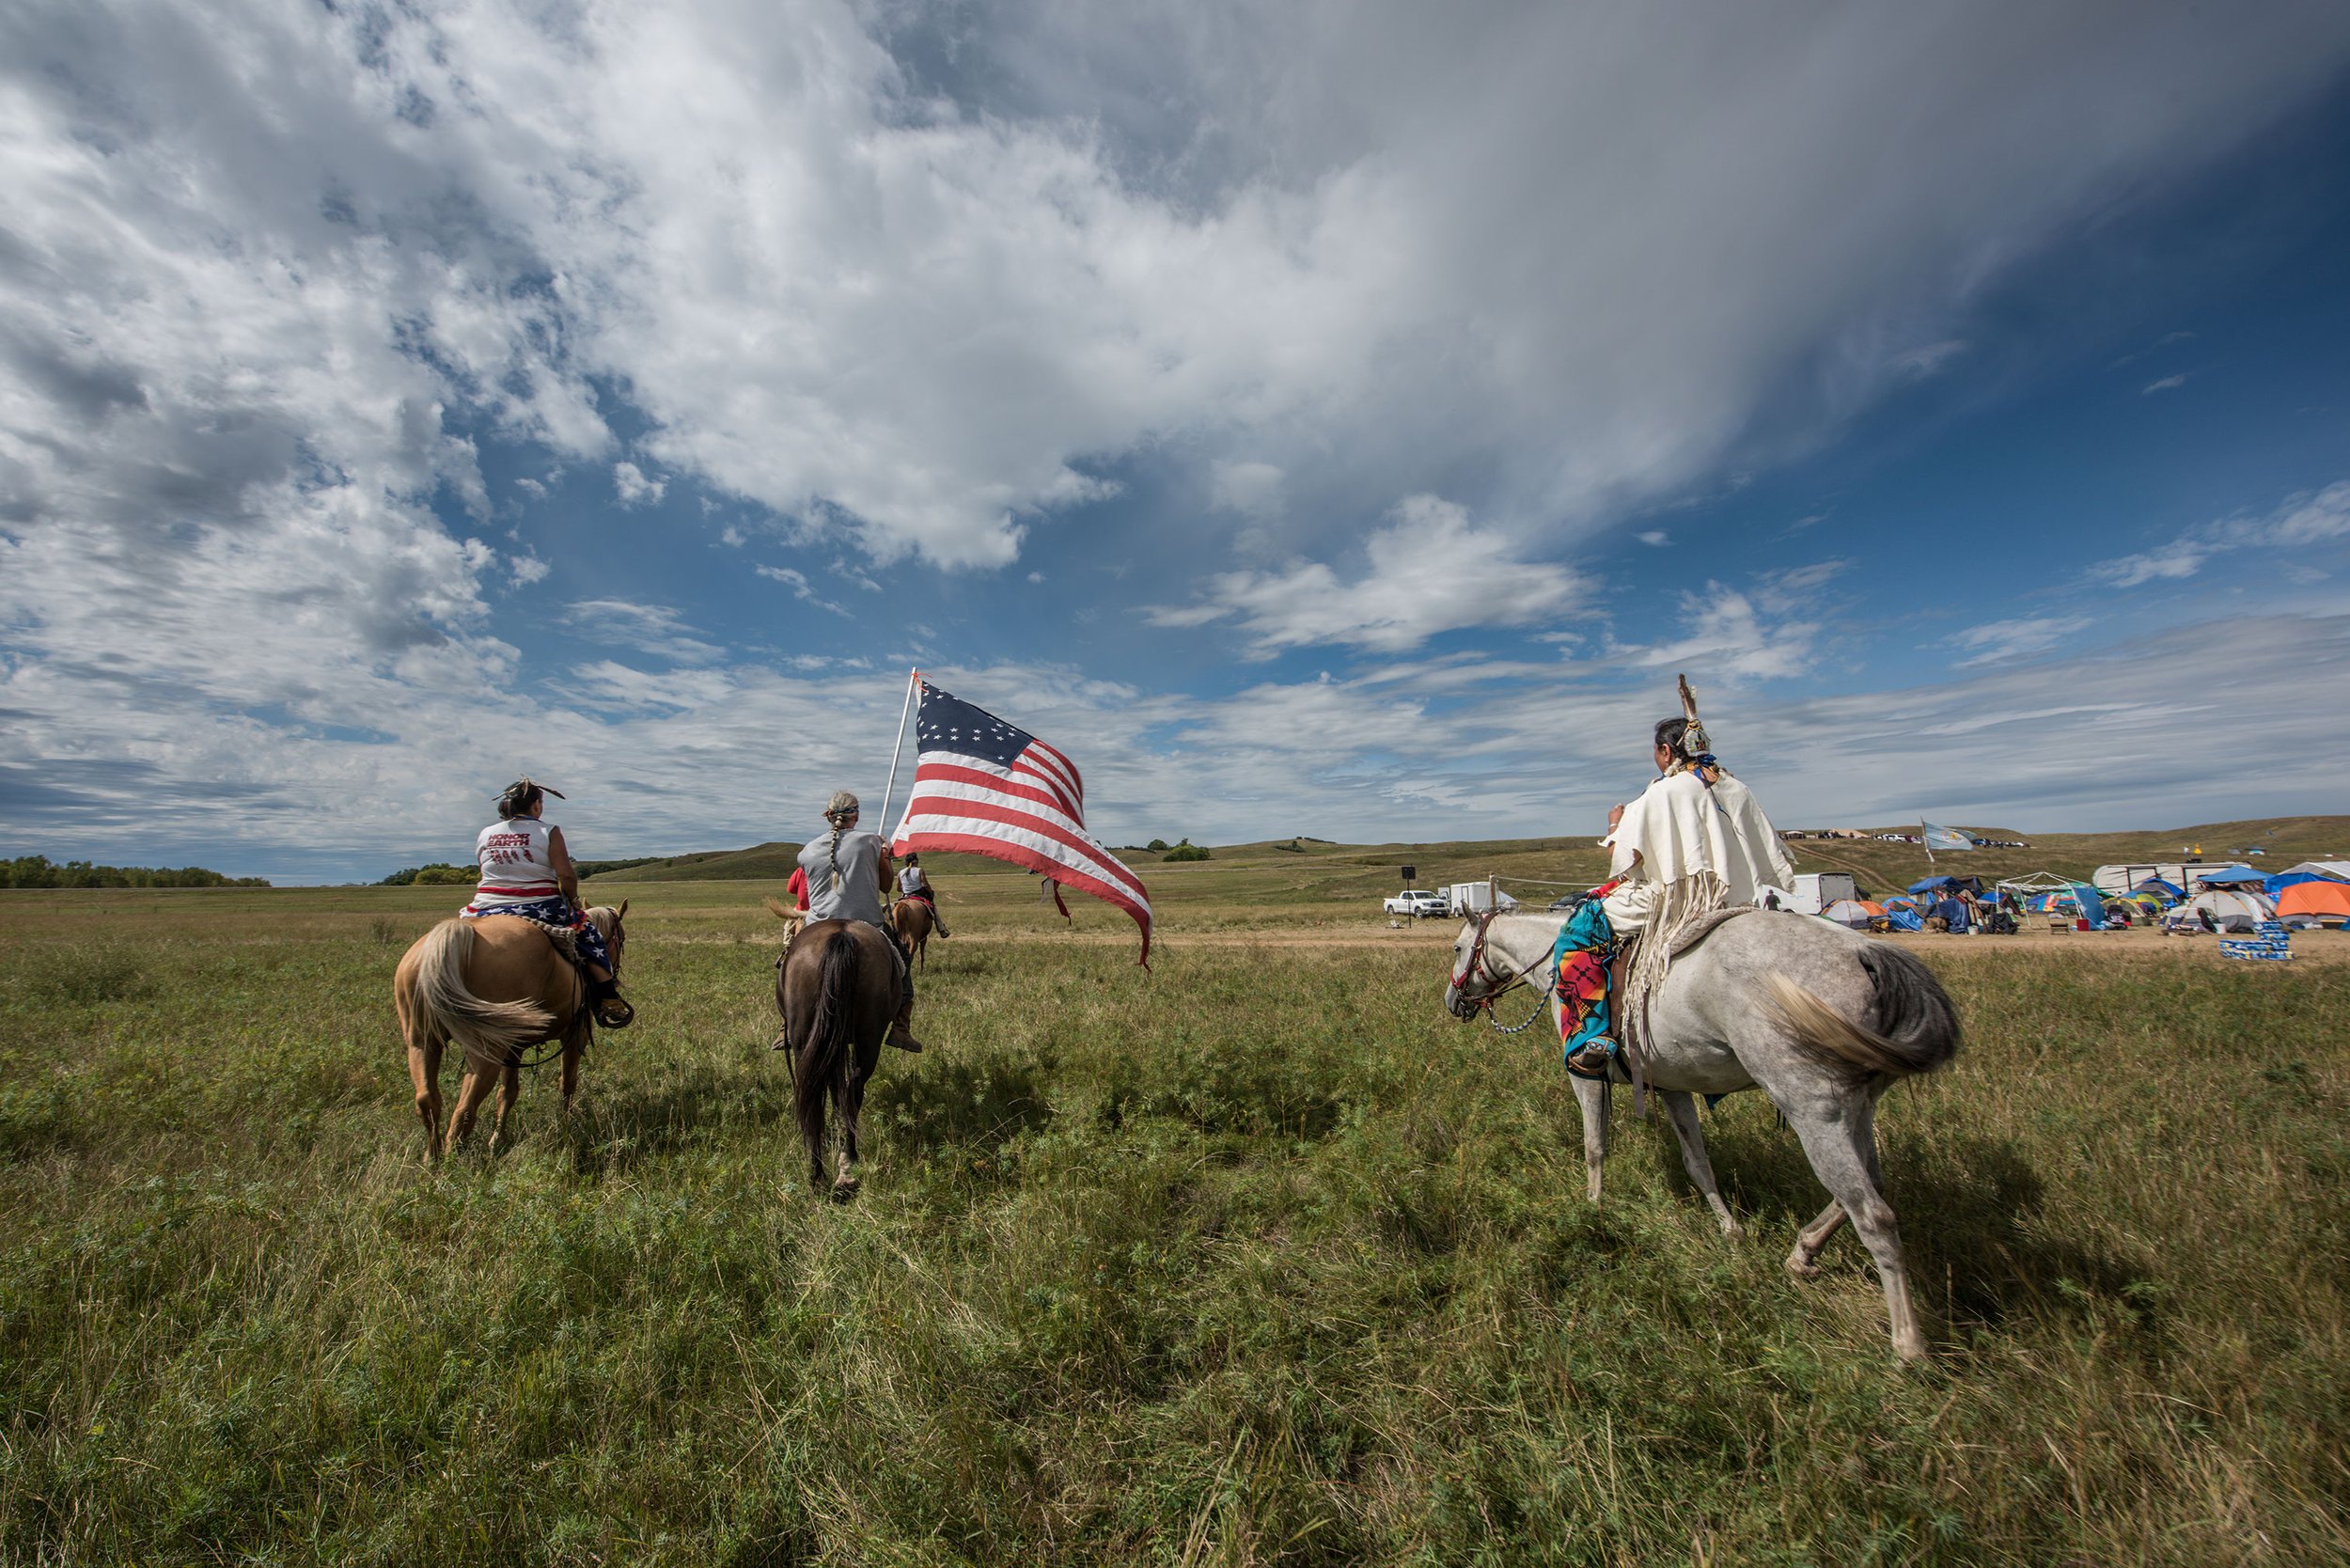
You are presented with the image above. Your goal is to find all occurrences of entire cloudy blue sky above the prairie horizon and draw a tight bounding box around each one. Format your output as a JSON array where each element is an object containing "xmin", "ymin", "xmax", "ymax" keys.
[{"xmin": 0, "ymin": 0, "xmax": 2350, "ymax": 879}]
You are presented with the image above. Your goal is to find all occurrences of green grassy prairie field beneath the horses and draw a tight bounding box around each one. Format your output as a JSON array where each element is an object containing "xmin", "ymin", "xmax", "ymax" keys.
[{"xmin": 0, "ymin": 879, "xmax": 2350, "ymax": 1565}]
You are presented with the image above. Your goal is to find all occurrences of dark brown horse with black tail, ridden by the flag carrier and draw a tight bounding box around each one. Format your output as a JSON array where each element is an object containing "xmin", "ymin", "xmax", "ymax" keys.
[{"xmin": 776, "ymin": 919, "xmax": 901, "ymax": 1203}]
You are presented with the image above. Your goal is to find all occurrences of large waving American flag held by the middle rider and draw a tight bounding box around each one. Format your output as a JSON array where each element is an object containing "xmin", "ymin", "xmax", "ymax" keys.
[{"xmin": 891, "ymin": 682, "xmax": 1152, "ymax": 964}]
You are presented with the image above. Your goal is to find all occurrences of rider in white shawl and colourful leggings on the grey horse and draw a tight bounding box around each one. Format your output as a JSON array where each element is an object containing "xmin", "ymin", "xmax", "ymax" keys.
[{"xmin": 1554, "ymin": 682, "xmax": 1795, "ymax": 1079}]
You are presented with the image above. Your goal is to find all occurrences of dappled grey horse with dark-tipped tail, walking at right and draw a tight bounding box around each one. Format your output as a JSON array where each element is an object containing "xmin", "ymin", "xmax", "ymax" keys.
[{"xmin": 1446, "ymin": 910, "xmax": 1958, "ymax": 1361}]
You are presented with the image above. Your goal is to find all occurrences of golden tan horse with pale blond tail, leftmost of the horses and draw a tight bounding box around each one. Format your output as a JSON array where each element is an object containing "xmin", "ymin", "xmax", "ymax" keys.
[{"xmin": 393, "ymin": 898, "xmax": 628, "ymax": 1159}]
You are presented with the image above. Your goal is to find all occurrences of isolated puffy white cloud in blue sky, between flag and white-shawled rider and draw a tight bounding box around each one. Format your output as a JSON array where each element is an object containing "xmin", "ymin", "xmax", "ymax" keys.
[{"xmin": 1145, "ymin": 496, "xmax": 1584, "ymax": 653}]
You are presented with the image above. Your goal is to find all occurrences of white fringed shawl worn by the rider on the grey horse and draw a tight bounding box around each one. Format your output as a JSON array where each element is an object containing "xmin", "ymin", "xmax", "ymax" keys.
[{"xmin": 1601, "ymin": 769, "xmax": 1795, "ymax": 931}]
